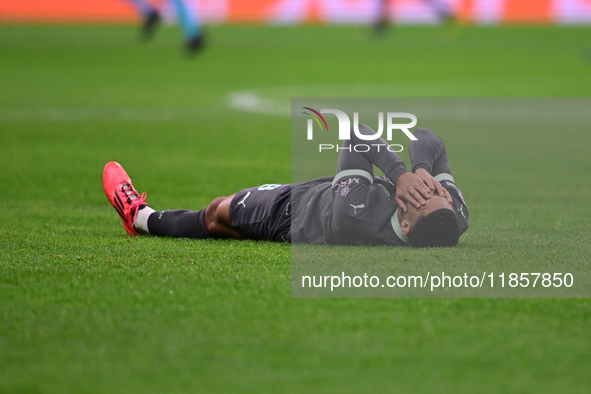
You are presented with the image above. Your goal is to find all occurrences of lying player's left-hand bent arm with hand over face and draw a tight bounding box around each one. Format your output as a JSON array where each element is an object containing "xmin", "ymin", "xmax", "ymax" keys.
[{"xmin": 335, "ymin": 124, "xmax": 431, "ymax": 212}]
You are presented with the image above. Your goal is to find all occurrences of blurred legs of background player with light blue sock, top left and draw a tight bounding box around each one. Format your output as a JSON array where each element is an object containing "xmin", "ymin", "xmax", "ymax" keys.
[{"xmin": 127, "ymin": 0, "xmax": 203, "ymax": 53}]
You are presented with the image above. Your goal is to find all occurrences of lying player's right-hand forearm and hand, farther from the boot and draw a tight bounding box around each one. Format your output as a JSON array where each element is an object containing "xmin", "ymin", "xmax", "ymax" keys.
[{"xmin": 408, "ymin": 128, "xmax": 452, "ymax": 204}]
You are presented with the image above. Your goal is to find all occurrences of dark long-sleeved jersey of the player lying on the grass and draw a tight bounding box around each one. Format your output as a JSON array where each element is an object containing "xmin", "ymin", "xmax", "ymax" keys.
[{"xmin": 291, "ymin": 126, "xmax": 469, "ymax": 245}]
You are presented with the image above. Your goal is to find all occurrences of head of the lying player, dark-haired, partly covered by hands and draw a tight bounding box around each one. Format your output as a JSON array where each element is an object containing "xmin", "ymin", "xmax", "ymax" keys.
[{"xmin": 400, "ymin": 196, "xmax": 460, "ymax": 248}]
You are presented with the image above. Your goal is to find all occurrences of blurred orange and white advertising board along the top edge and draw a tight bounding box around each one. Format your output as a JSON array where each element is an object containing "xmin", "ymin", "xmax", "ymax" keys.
[{"xmin": 0, "ymin": 0, "xmax": 591, "ymax": 24}]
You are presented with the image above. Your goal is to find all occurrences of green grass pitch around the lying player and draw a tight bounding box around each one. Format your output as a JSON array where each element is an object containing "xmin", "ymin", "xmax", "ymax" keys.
[{"xmin": 0, "ymin": 26, "xmax": 591, "ymax": 394}]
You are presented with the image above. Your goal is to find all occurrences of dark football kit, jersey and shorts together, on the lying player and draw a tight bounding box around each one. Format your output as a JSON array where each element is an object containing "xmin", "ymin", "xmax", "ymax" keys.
[{"xmin": 230, "ymin": 125, "xmax": 468, "ymax": 245}]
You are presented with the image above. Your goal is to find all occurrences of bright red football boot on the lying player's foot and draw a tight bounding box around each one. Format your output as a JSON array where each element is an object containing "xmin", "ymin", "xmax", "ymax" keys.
[{"xmin": 103, "ymin": 161, "xmax": 148, "ymax": 235}]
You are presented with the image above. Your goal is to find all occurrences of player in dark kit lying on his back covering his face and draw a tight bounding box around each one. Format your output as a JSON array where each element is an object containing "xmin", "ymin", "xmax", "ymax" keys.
[{"xmin": 103, "ymin": 125, "xmax": 468, "ymax": 247}]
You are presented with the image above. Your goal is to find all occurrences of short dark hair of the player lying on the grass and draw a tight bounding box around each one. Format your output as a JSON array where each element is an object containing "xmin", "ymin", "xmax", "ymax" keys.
[{"xmin": 408, "ymin": 208, "xmax": 461, "ymax": 248}]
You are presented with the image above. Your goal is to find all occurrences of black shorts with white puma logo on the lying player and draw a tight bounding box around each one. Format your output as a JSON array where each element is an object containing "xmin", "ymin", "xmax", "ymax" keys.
[{"xmin": 230, "ymin": 184, "xmax": 291, "ymax": 242}]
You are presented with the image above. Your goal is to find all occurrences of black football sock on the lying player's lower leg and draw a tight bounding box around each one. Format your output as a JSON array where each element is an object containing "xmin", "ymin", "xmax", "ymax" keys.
[{"xmin": 148, "ymin": 209, "xmax": 211, "ymax": 238}]
